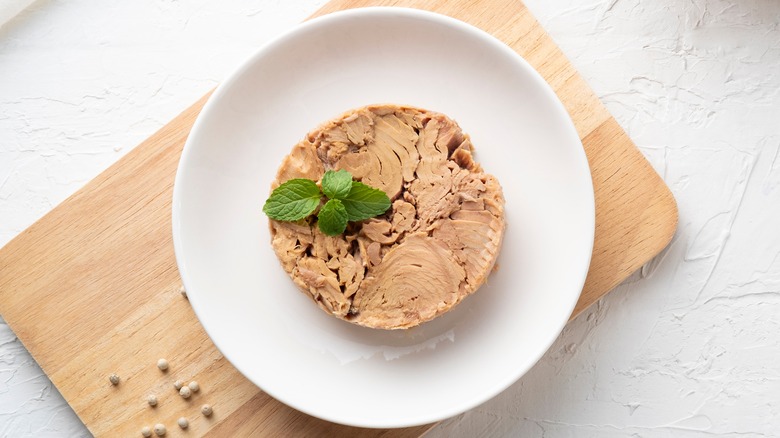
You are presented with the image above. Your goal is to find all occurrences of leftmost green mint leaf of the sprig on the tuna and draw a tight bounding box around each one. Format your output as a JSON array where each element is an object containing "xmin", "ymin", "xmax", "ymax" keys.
[{"xmin": 263, "ymin": 178, "xmax": 322, "ymax": 221}]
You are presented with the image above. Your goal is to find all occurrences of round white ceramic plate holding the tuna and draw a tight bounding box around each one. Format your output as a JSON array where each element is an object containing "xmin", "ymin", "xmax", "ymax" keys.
[{"xmin": 173, "ymin": 8, "xmax": 594, "ymax": 427}]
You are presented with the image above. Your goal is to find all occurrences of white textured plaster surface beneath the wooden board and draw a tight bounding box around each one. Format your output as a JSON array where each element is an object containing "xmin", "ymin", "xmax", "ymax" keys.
[{"xmin": 0, "ymin": 0, "xmax": 780, "ymax": 438}]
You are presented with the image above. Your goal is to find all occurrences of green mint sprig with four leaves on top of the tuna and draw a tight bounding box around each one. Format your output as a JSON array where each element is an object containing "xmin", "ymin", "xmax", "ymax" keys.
[{"xmin": 263, "ymin": 170, "xmax": 390, "ymax": 236}]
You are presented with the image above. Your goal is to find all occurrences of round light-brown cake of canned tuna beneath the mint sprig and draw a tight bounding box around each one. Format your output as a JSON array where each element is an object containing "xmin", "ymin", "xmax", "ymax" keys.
[{"xmin": 270, "ymin": 105, "xmax": 505, "ymax": 329}]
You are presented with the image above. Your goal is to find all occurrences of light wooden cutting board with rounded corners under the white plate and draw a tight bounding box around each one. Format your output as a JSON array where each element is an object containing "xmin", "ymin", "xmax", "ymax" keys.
[{"xmin": 0, "ymin": 0, "xmax": 677, "ymax": 437}]
